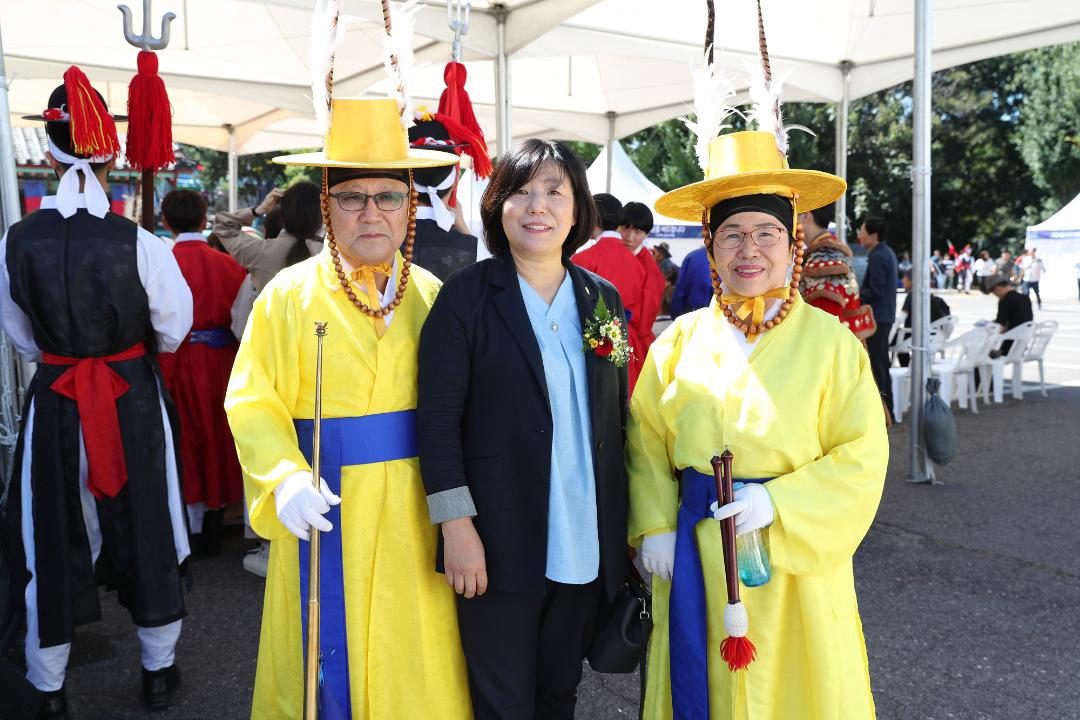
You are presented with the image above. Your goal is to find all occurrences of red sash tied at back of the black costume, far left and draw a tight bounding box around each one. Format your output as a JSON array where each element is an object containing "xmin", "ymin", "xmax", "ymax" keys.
[{"xmin": 41, "ymin": 343, "xmax": 146, "ymax": 500}]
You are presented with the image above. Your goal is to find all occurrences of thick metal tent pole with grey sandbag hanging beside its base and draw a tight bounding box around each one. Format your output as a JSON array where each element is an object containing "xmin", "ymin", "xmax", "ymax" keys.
[{"xmin": 908, "ymin": 0, "xmax": 934, "ymax": 483}]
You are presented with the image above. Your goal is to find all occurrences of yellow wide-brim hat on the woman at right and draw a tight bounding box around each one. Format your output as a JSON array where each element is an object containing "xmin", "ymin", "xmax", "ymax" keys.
[{"xmin": 656, "ymin": 131, "xmax": 848, "ymax": 222}]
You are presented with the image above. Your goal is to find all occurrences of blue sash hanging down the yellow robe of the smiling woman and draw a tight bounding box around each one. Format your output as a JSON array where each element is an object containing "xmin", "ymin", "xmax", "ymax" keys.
[{"xmin": 667, "ymin": 467, "xmax": 772, "ymax": 720}]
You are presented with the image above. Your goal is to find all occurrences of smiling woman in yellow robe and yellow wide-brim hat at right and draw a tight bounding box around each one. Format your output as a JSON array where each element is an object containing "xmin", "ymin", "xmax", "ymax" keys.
[{"xmin": 627, "ymin": 126, "xmax": 888, "ymax": 720}]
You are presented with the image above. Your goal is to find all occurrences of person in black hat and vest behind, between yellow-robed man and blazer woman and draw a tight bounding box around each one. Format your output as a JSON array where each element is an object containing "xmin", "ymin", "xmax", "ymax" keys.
[{"xmin": 408, "ymin": 114, "xmax": 477, "ymax": 281}]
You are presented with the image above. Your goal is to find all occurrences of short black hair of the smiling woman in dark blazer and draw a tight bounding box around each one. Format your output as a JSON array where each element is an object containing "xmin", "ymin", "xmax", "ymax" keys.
[{"xmin": 480, "ymin": 137, "xmax": 596, "ymax": 258}]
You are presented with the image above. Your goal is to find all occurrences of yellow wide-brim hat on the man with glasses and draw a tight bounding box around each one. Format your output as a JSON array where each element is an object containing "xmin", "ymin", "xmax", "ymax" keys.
[{"xmin": 273, "ymin": 97, "xmax": 458, "ymax": 169}]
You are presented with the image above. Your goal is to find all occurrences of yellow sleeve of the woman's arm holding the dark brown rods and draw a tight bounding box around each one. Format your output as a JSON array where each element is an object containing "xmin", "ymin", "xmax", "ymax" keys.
[{"xmin": 766, "ymin": 325, "xmax": 889, "ymax": 575}]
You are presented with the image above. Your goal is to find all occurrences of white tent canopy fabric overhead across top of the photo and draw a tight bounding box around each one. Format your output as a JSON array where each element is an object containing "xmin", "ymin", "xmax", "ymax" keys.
[{"xmin": 0, "ymin": 0, "xmax": 1080, "ymax": 152}]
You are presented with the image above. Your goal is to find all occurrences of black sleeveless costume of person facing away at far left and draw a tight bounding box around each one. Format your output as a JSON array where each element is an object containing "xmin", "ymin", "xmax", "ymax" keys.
[{"xmin": 5, "ymin": 209, "xmax": 184, "ymax": 647}]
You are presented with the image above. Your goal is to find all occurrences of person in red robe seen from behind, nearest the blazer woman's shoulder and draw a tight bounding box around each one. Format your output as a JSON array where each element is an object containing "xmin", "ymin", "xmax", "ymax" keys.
[{"xmin": 570, "ymin": 192, "xmax": 645, "ymax": 393}]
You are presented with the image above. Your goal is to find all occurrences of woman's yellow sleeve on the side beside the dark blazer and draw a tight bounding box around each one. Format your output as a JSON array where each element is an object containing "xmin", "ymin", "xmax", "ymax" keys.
[{"xmin": 626, "ymin": 322, "xmax": 680, "ymax": 546}]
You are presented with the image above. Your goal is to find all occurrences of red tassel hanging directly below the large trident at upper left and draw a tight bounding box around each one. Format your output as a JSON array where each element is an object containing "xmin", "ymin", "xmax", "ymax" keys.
[{"xmin": 127, "ymin": 50, "xmax": 176, "ymax": 171}]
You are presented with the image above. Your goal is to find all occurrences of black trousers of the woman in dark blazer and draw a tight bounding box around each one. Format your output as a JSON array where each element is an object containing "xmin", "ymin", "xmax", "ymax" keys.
[{"xmin": 458, "ymin": 580, "xmax": 600, "ymax": 720}]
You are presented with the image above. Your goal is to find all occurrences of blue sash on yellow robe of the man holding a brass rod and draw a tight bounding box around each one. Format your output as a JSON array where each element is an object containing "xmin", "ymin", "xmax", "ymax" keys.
[{"xmin": 294, "ymin": 410, "xmax": 417, "ymax": 720}]
